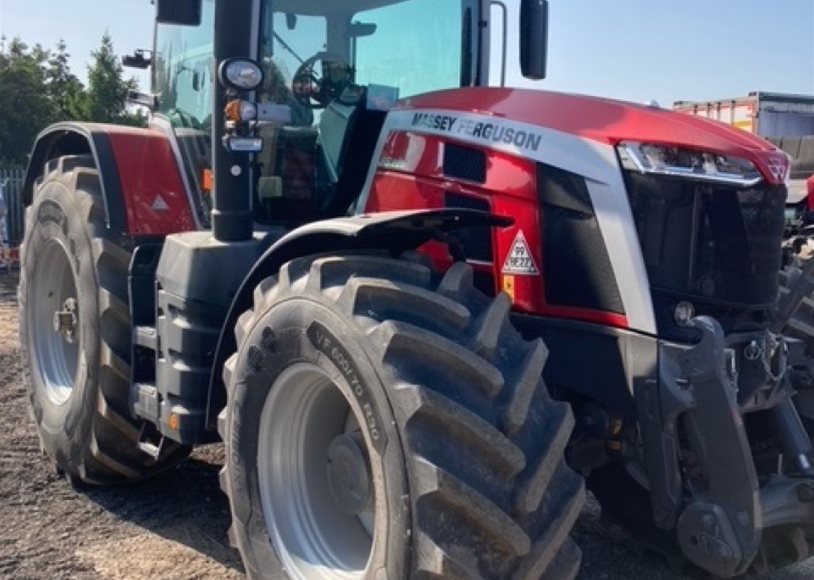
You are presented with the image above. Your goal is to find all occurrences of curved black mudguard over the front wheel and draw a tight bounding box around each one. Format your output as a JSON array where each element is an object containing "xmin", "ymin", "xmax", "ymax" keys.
[{"xmin": 207, "ymin": 209, "xmax": 514, "ymax": 430}]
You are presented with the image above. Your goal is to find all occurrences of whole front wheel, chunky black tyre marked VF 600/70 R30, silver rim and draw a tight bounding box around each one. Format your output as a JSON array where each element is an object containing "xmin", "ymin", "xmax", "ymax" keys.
[{"xmin": 219, "ymin": 255, "xmax": 584, "ymax": 580}]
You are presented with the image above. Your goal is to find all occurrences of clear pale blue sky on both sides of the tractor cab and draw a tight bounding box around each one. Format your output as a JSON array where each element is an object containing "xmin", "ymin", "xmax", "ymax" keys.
[{"xmin": 0, "ymin": 0, "xmax": 814, "ymax": 106}]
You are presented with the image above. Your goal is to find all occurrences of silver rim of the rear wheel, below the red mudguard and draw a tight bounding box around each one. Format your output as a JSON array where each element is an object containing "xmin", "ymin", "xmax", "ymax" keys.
[{"xmin": 28, "ymin": 240, "xmax": 81, "ymax": 405}]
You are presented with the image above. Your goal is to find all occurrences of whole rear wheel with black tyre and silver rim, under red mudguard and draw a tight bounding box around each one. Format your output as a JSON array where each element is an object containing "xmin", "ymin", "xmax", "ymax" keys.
[{"xmin": 19, "ymin": 156, "xmax": 189, "ymax": 484}]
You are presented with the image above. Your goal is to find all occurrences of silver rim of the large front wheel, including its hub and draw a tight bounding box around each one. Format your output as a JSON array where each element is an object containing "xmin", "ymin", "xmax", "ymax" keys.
[{"xmin": 258, "ymin": 363, "xmax": 377, "ymax": 580}]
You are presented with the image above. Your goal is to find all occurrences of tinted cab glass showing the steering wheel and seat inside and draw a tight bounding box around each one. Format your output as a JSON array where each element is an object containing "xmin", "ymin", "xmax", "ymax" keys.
[{"xmin": 254, "ymin": 0, "xmax": 471, "ymax": 223}]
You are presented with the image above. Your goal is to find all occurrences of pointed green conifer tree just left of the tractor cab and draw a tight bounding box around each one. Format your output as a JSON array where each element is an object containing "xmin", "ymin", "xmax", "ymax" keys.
[{"xmin": 79, "ymin": 33, "xmax": 144, "ymax": 125}]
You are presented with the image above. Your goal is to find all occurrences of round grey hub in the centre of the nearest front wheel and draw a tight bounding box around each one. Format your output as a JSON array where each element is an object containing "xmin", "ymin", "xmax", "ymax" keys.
[{"xmin": 327, "ymin": 431, "xmax": 373, "ymax": 516}]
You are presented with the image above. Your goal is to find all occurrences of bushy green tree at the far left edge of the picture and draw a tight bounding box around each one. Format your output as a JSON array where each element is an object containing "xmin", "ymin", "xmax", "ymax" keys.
[{"xmin": 0, "ymin": 38, "xmax": 58, "ymax": 164}]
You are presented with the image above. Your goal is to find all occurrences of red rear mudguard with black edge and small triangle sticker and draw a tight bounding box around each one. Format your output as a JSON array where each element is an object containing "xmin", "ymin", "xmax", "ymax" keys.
[{"xmin": 23, "ymin": 122, "xmax": 196, "ymax": 236}]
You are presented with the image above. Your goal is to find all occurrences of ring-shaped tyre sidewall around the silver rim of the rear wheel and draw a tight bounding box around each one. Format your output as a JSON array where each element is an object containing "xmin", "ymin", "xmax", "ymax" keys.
[{"xmin": 19, "ymin": 179, "xmax": 99, "ymax": 467}]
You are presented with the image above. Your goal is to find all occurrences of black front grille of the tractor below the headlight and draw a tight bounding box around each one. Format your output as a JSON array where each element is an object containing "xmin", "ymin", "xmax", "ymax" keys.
[{"xmin": 625, "ymin": 173, "xmax": 786, "ymax": 332}]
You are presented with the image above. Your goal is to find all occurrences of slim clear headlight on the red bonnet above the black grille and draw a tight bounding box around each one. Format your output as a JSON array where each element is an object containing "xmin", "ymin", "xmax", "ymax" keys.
[{"xmin": 618, "ymin": 141, "xmax": 763, "ymax": 187}]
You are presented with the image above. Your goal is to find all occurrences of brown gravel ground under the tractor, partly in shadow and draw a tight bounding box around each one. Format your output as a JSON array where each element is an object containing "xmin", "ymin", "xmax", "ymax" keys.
[{"xmin": 0, "ymin": 274, "xmax": 814, "ymax": 580}]
